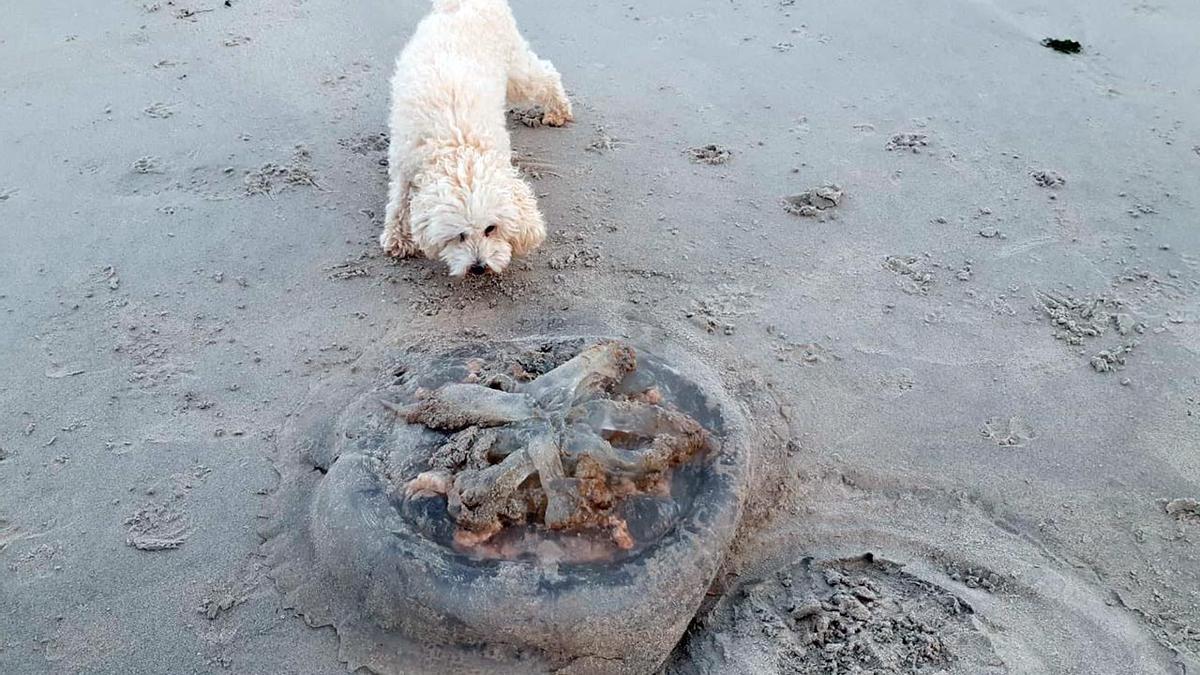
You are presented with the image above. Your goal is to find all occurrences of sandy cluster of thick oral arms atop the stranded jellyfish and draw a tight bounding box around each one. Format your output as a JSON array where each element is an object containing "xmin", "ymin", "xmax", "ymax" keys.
[{"xmin": 389, "ymin": 341, "xmax": 710, "ymax": 551}]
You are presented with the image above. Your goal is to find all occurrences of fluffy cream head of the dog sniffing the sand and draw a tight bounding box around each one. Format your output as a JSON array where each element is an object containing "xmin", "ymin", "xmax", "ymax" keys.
[{"xmin": 409, "ymin": 151, "xmax": 545, "ymax": 276}]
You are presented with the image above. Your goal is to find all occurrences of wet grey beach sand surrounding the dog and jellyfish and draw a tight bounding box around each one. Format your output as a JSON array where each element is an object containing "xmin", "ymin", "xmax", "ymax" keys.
[{"xmin": 0, "ymin": 0, "xmax": 1200, "ymax": 674}]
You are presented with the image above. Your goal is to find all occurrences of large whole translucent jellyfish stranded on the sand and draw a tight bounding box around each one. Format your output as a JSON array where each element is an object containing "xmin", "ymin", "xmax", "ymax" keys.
[{"xmin": 263, "ymin": 338, "xmax": 749, "ymax": 674}]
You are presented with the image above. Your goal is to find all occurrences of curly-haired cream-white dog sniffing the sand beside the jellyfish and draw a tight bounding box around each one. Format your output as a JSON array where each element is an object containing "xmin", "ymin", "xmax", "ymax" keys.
[{"xmin": 379, "ymin": 0, "xmax": 572, "ymax": 276}]
